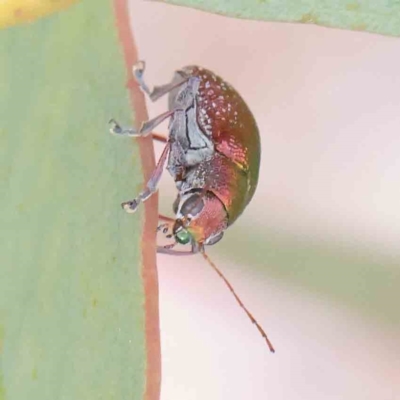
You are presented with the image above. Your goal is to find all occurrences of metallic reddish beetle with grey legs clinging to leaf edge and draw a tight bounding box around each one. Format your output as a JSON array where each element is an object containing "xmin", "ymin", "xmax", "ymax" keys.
[{"xmin": 110, "ymin": 61, "xmax": 274, "ymax": 351}]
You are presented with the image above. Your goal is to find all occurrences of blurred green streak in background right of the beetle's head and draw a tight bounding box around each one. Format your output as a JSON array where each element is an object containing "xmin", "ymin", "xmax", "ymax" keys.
[{"xmin": 220, "ymin": 226, "xmax": 400, "ymax": 329}]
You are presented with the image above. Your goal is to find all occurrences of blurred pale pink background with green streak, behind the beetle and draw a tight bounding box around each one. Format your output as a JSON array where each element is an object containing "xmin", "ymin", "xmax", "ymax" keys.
[{"xmin": 131, "ymin": 0, "xmax": 400, "ymax": 400}]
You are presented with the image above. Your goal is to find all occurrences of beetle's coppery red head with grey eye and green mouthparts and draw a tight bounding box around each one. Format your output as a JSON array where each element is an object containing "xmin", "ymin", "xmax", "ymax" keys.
[{"xmin": 172, "ymin": 191, "xmax": 228, "ymax": 248}]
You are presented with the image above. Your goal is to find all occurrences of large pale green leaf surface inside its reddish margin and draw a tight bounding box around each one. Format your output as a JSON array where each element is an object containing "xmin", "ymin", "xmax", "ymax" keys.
[{"xmin": 0, "ymin": 0, "xmax": 156, "ymax": 400}]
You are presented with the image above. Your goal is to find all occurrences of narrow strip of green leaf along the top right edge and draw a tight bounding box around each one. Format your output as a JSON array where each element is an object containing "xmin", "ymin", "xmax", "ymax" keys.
[{"xmin": 158, "ymin": 0, "xmax": 400, "ymax": 36}]
